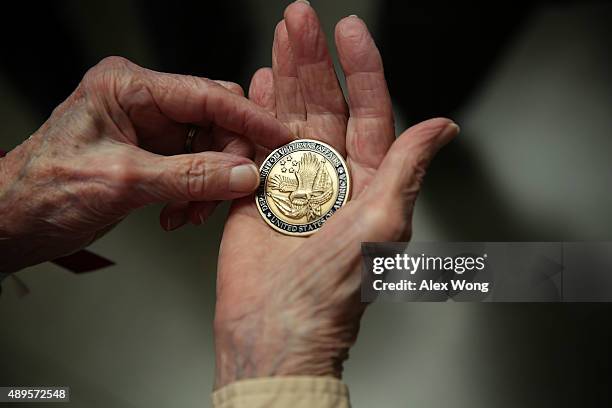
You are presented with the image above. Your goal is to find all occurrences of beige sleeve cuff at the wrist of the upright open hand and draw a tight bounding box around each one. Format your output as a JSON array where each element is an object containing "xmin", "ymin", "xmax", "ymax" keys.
[{"xmin": 212, "ymin": 376, "xmax": 350, "ymax": 408}]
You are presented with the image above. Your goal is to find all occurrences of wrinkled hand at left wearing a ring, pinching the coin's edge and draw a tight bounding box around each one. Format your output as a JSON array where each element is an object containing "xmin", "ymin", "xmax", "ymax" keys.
[{"xmin": 0, "ymin": 57, "xmax": 292, "ymax": 272}]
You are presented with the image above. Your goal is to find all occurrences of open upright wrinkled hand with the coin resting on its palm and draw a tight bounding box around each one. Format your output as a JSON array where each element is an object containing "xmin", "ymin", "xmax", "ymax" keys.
[{"xmin": 215, "ymin": 2, "xmax": 458, "ymax": 387}]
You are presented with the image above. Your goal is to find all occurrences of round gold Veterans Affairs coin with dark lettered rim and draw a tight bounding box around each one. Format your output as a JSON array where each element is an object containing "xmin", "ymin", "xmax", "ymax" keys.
[{"xmin": 255, "ymin": 139, "xmax": 351, "ymax": 236}]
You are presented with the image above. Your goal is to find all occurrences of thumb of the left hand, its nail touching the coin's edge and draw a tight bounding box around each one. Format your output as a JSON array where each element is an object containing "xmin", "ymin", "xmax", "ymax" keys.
[{"xmin": 140, "ymin": 152, "xmax": 259, "ymax": 203}]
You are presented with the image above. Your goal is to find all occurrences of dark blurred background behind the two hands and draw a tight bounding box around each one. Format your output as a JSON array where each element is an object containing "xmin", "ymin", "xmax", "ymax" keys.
[{"xmin": 0, "ymin": 0, "xmax": 612, "ymax": 407}]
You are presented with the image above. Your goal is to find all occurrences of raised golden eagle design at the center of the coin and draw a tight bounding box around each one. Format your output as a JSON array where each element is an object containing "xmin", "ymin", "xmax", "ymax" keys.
[{"xmin": 267, "ymin": 153, "xmax": 333, "ymax": 222}]
